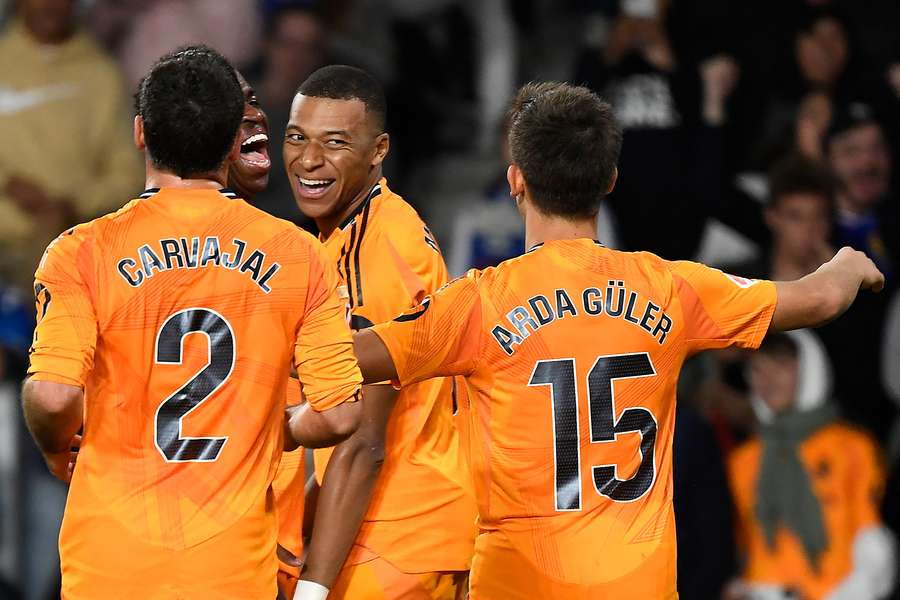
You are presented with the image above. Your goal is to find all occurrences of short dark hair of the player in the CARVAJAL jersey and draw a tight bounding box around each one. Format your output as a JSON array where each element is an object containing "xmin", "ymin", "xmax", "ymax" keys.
[{"xmin": 135, "ymin": 45, "xmax": 244, "ymax": 177}]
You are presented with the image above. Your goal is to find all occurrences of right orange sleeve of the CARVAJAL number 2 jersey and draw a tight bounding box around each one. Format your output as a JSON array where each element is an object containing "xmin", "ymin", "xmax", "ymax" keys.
[{"xmin": 294, "ymin": 243, "xmax": 362, "ymax": 411}]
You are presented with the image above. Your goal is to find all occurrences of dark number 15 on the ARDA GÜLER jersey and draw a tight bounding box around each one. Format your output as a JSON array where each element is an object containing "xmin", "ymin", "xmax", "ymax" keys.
[{"xmin": 528, "ymin": 352, "xmax": 657, "ymax": 511}]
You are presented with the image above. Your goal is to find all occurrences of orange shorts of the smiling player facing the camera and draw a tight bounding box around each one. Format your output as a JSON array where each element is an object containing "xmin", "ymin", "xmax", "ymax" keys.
[{"xmin": 328, "ymin": 556, "xmax": 468, "ymax": 600}]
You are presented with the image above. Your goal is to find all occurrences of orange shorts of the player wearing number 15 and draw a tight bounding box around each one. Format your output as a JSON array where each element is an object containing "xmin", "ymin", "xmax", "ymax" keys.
[{"xmin": 469, "ymin": 531, "xmax": 678, "ymax": 600}]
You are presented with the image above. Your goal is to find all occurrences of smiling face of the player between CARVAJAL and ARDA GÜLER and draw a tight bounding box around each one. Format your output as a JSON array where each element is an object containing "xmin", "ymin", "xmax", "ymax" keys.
[{"xmin": 284, "ymin": 94, "xmax": 387, "ymax": 228}]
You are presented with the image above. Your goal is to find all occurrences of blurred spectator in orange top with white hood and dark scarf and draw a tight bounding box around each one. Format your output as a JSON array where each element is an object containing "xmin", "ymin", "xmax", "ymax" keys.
[{"xmin": 728, "ymin": 331, "xmax": 896, "ymax": 600}]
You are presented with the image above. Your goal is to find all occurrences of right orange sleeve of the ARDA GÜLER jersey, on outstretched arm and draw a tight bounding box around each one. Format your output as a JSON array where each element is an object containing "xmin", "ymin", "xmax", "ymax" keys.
[{"xmin": 668, "ymin": 261, "xmax": 777, "ymax": 352}]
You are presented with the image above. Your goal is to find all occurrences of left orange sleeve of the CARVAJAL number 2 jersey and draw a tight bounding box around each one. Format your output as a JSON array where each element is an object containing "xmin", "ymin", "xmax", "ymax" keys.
[{"xmin": 28, "ymin": 230, "xmax": 97, "ymax": 387}]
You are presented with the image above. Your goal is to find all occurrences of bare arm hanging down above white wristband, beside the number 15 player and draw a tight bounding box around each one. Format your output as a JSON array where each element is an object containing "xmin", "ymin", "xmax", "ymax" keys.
[{"xmin": 297, "ymin": 385, "xmax": 397, "ymax": 598}]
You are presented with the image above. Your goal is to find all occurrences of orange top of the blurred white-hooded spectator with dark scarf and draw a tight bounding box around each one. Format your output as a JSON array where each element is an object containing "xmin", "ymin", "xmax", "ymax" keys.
[{"xmin": 728, "ymin": 423, "xmax": 884, "ymax": 600}]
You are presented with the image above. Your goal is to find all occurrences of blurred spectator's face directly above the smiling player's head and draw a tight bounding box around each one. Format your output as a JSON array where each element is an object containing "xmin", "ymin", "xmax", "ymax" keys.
[{"xmin": 266, "ymin": 11, "xmax": 325, "ymax": 86}]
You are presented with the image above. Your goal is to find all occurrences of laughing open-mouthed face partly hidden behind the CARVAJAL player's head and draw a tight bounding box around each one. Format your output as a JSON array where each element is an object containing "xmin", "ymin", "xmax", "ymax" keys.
[{"xmin": 228, "ymin": 73, "xmax": 272, "ymax": 200}]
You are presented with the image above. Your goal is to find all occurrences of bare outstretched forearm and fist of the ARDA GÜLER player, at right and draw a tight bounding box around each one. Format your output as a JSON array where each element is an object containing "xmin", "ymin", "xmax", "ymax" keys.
[{"xmin": 769, "ymin": 247, "xmax": 884, "ymax": 331}]
